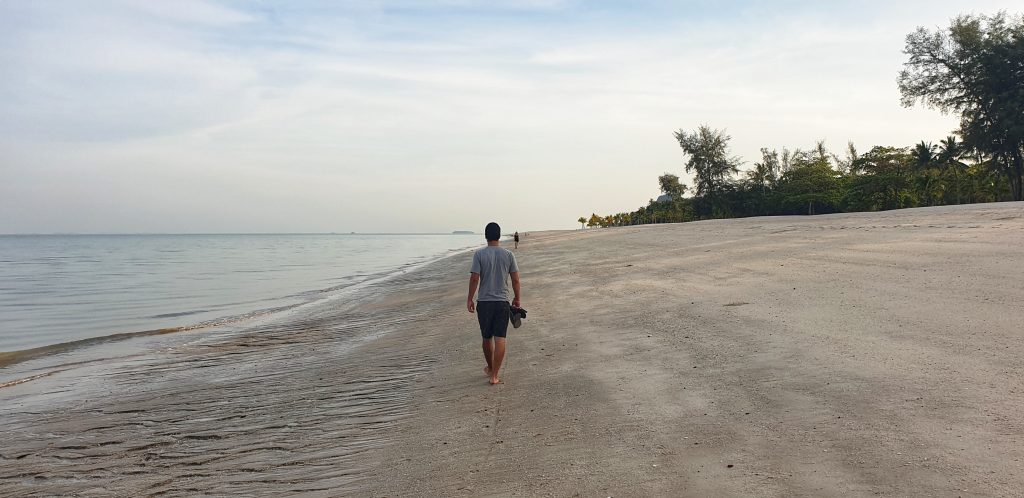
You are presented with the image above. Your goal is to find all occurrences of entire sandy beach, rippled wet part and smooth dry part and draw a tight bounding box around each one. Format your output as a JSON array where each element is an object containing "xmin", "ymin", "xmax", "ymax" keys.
[{"xmin": 0, "ymin": 203, "xmax": 1024, "ymax": 497}]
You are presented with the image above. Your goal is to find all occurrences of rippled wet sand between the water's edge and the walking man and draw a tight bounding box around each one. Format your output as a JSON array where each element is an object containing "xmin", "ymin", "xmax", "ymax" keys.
[{"xmin": 0, "ymin": 266, "xmax": 448, "ymax": 496}]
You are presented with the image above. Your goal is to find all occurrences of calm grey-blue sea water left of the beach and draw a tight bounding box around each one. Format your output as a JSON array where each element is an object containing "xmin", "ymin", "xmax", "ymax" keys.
[{"xmin": 0, "ymin": 235, "xmax": 483, "ymax": 351}]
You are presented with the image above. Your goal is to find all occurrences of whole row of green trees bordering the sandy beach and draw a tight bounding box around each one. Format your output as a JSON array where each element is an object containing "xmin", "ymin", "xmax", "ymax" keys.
[{"xmin": 577, "ymin": 12, "xmax": 1024, "ymax": 226}]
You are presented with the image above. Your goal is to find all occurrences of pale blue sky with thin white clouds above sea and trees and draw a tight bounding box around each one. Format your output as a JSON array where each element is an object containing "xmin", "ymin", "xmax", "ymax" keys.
[{"xmin": 0, "ymin": 0, "xmax": 1024, "ymax": 234}]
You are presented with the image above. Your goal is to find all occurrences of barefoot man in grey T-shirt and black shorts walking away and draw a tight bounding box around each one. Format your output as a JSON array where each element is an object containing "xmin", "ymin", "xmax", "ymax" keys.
[{"xmin": 466, "ymin": 221, "xmax": 520, "ymax": 385}]
